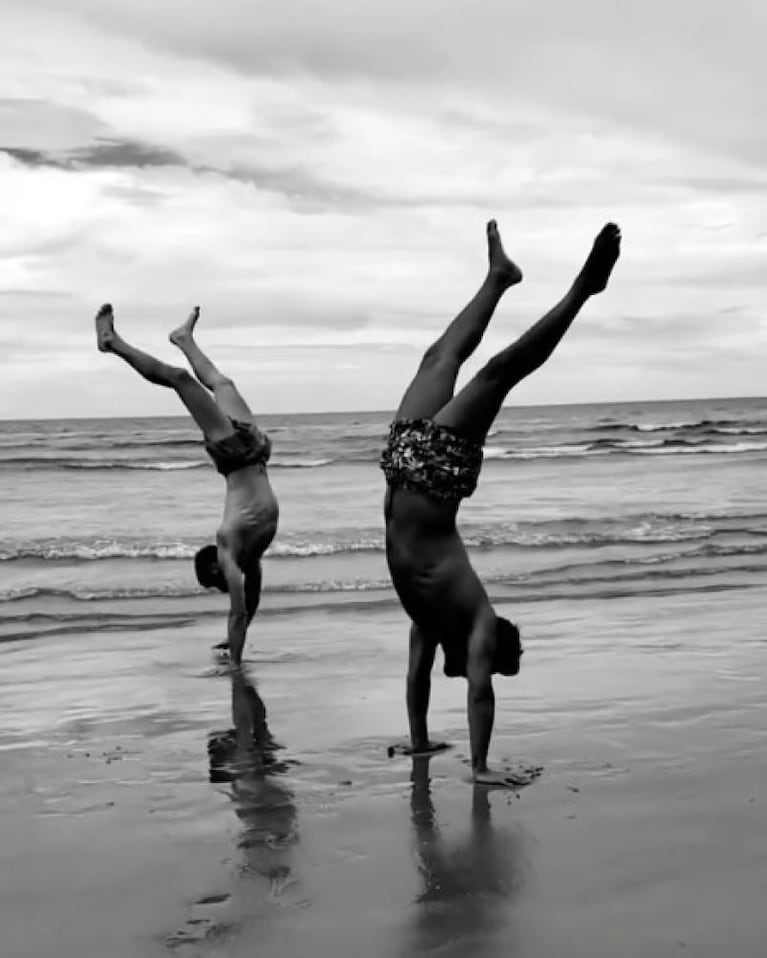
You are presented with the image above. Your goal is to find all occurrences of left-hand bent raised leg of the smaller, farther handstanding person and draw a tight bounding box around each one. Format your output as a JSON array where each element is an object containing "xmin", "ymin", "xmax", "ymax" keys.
[{"xmin": 96, "ymin": 303, "xmax": 232, "ymax": 442}]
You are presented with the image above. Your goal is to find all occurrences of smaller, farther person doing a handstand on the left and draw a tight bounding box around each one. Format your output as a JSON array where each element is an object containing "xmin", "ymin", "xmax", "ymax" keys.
[{"xmin": 96, "ymin": 304, "xmax": 279, "ymax": 666}]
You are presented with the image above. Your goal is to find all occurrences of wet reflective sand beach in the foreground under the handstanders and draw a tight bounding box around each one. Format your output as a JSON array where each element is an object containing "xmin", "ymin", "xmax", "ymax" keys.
[{"xmin": 0, "ymin": 588, "xmax": 767, "ymax": 958}]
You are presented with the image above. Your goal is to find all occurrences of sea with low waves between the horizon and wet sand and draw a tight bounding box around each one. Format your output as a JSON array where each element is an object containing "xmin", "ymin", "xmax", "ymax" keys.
[{"xmin": 0, "ymin": 399, "xmax": 767, "ymax": 643}]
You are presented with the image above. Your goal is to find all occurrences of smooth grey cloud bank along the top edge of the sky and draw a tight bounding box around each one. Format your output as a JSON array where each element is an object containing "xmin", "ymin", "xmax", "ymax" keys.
[{"xmin": 15, "ymin": 0, "xmax": 767, "ymax": 158}]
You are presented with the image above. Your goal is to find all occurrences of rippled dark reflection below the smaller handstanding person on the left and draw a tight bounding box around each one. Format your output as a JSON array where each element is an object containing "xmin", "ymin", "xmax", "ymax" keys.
[{"xmin": 208, "ymin": 669, "xmax": 298, "ymax": 898}]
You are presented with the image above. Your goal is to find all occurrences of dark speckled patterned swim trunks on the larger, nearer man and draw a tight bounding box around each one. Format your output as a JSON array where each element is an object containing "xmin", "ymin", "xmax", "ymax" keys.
[{"xmin": 381, "ymin": 419, "xmax": 482, "ymax": 510}]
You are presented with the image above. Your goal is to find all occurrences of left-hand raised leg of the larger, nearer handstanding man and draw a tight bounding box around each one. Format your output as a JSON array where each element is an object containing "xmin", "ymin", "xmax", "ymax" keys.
[{"xmin": 396, "ymin": 220, "xmax": 522, "ymax": 420}]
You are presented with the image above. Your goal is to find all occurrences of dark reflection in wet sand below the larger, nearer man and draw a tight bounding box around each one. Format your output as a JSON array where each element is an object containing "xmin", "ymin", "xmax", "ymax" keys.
[{"xmin": 408, "ymin": 756, "xmax": 526, "ymax": 955}]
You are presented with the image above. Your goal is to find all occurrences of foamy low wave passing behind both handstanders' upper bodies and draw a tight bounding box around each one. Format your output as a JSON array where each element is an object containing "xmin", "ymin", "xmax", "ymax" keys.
[{"xmin": 0, "ymin": 512, "xmax": 767, "ymax": 562}]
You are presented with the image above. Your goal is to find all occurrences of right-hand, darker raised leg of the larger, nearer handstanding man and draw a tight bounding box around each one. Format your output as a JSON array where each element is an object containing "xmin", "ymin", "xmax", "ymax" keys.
[{"xmin": 435, "ymin": 223, "xmax": 621, "ymax": 442}]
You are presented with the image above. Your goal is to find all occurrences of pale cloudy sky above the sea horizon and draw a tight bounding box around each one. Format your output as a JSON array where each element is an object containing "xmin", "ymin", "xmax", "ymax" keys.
[{"xmin": 0, "ymin": 0, "xmax": 767, "ymax": 418}]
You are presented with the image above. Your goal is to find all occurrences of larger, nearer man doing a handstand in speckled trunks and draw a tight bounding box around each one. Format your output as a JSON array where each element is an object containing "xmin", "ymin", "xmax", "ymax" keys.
[{"xmin": 381, "ymin": 220, "xmax": 621, "ymax": 786}]
